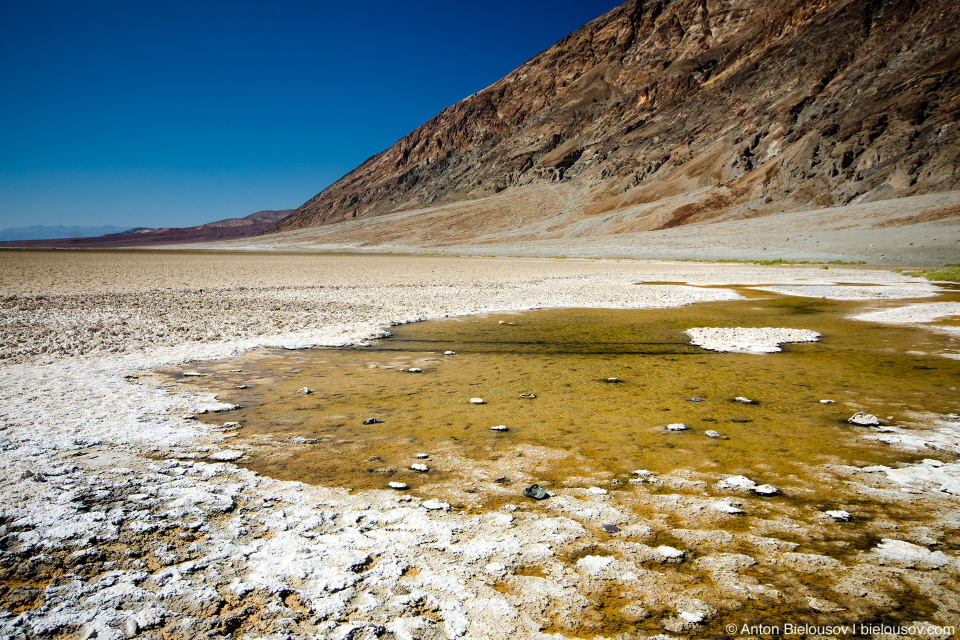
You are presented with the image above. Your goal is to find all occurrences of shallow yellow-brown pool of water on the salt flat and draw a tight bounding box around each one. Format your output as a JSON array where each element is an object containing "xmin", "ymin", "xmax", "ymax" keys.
[{"xmin": 168, "ymin": 290, "xmax": 960, "ymax": 496}]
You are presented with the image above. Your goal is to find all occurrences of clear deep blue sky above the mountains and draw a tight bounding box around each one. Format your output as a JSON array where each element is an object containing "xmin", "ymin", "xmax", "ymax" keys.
[{"xmin": 0, "ymin": 0, "xmax": 619, "ymax": 228}]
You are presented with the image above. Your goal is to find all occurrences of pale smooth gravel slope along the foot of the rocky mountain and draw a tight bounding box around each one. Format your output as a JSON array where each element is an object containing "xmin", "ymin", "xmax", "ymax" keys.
[{"xmin": 201, "ymin": 187, "xmax": 960, "ymax": 265}]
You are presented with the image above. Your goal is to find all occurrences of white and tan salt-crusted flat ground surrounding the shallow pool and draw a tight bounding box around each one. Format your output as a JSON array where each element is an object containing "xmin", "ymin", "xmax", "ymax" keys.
[{"xmin": 0, "ymin": 252, "xmax": 960, "ymax": 639}]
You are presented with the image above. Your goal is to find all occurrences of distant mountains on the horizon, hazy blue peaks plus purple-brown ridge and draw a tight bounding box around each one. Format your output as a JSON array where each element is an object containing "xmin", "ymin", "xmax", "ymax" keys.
[{"xmin": 0, "ymin": 209, "xmax": 293, "ymax": 249}]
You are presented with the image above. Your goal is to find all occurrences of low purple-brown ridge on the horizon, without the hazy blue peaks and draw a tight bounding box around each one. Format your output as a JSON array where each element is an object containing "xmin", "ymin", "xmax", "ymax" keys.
[{"xmin": 0, "ymin": 209, "xmax": 294, "ymax": 249}]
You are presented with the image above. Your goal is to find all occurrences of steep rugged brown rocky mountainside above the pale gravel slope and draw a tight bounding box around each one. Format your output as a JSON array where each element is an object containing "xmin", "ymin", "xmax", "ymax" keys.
[{"xmin": 271, "ymin": 0, "xmax": 960, "ymax": 233}]
